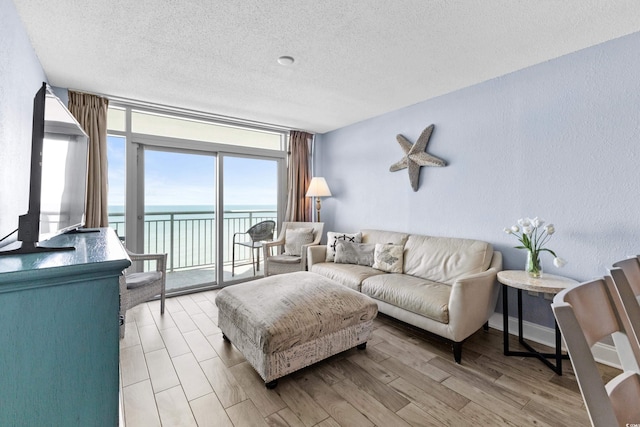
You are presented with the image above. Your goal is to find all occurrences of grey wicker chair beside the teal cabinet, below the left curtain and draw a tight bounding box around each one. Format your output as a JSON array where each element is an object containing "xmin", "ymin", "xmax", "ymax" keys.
[{"xmin": 120, "ymin": 250, "xmax": 167, "ymax": 338}]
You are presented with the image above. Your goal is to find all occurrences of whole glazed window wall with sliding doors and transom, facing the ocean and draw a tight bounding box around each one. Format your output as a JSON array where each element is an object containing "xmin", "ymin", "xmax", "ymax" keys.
[{"xmin": 108, "ymin": 103, "xmax": 287, "ymax": 293}]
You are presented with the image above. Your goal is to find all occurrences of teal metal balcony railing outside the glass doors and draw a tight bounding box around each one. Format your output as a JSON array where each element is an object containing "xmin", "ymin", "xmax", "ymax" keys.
[{"xmin": 109, "ymin": 210, "xmax": 277, "ymax": 271}]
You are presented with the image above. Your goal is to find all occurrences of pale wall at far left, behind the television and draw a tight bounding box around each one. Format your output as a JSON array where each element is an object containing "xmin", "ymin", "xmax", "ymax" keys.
[{"xmin": 0, "ymin": 0, "xmax": 47, "ymax": 245}]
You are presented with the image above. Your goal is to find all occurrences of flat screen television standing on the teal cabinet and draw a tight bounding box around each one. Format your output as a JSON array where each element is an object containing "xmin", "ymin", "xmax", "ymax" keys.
[{"xmin": 0, "ymin": 83, "xmax": 89, "ymax": 255}]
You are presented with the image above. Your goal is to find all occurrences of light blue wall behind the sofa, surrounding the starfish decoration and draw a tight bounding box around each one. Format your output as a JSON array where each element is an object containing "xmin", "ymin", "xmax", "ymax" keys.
[{"xmin": 315, "ymin": 33, "xmax": 640, "ymax": 326}]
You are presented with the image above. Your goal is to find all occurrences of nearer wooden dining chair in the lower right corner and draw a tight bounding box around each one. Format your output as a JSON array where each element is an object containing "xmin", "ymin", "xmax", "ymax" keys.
[{"xmin": 551, "ymin": 276, "xmax": 640, "ymax": 427}]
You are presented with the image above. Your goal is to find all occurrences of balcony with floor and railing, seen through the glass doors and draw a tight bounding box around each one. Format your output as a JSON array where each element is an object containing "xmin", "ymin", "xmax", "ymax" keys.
[{"xmin": 109, "ymin": 210, "xmax": 277, "ymax": 292}]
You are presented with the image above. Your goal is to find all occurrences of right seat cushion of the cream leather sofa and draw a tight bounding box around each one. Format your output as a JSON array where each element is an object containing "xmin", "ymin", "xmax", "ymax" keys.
[{"xmin": 362, "ymin": 274, "xmax": 451, "ymax": 323}]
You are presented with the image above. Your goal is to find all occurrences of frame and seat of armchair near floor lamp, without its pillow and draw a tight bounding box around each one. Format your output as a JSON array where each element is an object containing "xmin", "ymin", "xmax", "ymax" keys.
[{"xmin": 262, "ymin": 222, "xmax": 324, "ymax": 276}]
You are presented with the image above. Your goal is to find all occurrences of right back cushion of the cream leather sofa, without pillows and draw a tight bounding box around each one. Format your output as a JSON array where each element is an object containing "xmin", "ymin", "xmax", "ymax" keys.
[{"xmin": 404, "ymin": 235, "xmax": 493, "ymax": 285}]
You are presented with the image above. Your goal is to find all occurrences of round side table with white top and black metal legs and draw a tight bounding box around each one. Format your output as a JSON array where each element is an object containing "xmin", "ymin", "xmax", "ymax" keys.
[{"xmin": 498, "ymin": 270, "xmax": 578, "ymax": 375}]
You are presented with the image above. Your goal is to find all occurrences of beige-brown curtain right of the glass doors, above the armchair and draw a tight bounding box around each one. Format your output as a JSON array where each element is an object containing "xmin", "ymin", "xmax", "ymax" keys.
[{"xmin": 285, "ymin": 131, "xmax": 313, "ymax": 222}]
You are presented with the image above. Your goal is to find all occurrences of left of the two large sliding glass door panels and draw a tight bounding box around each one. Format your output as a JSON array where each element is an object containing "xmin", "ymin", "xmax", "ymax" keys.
[{"xmin": 142, "ymin": 148, "xmax": 217, "ymax": 292}]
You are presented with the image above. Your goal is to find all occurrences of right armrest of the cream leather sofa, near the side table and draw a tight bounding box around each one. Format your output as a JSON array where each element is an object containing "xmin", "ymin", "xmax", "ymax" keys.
[{"xmin": 449, "ymin": 268, "xmax": 500, "ymax": 341}]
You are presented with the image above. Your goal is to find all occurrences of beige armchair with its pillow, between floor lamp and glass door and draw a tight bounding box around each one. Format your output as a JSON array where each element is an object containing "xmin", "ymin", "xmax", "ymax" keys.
[{"xmin": 262, "ymin": 222, "xmax": 324, "ymax": 276}]
